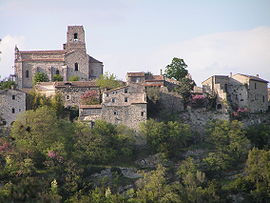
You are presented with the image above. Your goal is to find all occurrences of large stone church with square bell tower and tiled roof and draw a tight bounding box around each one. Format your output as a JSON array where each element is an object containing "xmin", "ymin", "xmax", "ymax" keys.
[{"xmin": 15, "ymin": 26, "xmax": 103, "ymax": 88}]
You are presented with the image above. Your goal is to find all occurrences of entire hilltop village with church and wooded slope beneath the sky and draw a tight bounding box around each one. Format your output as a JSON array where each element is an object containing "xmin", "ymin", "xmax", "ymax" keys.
[{"xmin": 0, "ymin": 26, "xmax": 270, "ymax": 203}]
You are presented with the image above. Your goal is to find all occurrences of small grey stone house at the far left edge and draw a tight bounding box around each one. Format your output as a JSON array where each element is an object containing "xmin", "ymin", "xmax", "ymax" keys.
[{"xmin": 0, "ymin": 89, "xmax": 26, "ymax": 126}]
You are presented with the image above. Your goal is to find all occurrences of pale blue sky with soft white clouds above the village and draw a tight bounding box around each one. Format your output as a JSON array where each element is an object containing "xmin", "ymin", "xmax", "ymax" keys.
[{"xmin": 0, "ymin": 0, "xmax": 270, "ymax": 86}]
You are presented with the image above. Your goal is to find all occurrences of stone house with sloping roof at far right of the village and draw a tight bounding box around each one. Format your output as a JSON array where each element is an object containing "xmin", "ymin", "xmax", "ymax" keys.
[{"xmin": 202, "ymin": 73, "xmax": 268, "ymax": 113}]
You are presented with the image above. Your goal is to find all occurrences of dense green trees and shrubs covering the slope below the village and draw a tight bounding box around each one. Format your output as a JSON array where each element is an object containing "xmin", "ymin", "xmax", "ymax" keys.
[{"xmin": 0, "ymin": 99, "xmax": 270, "ymax": 203}]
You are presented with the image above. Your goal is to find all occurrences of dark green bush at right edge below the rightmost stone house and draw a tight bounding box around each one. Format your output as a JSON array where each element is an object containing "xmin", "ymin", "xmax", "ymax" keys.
[{"xmin": 247, "ymin": 124, "xmax": 270, "ymax": 149}]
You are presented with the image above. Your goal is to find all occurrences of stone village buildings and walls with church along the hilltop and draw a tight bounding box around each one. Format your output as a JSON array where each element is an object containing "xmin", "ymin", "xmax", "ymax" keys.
[{"xmin": 0, "ymin": 26, "xmax": 269, "ymax": 129}]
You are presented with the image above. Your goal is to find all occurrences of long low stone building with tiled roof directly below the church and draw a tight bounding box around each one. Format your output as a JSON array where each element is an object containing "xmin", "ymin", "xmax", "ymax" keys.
[{"xmin": 35, "ymin": 80, "xmax": 100, "ymax": 107}]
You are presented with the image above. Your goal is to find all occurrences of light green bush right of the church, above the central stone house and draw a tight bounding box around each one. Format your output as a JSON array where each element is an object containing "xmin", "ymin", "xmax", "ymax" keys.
[{"xmin": 96, "ymin": 72, "xmax": 121, "ymax": 89}]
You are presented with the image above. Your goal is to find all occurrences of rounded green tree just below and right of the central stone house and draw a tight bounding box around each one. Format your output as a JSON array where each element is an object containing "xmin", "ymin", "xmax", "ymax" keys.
[{"xmin": 140, "ymin": 119, "xmax": 192, "ymax": 155}]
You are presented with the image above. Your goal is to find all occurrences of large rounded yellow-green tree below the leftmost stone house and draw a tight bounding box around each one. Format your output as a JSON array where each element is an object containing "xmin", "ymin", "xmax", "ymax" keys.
[{"xmin": 11, "ymin": 107, "xmax": 74, "ymax": 156}]
